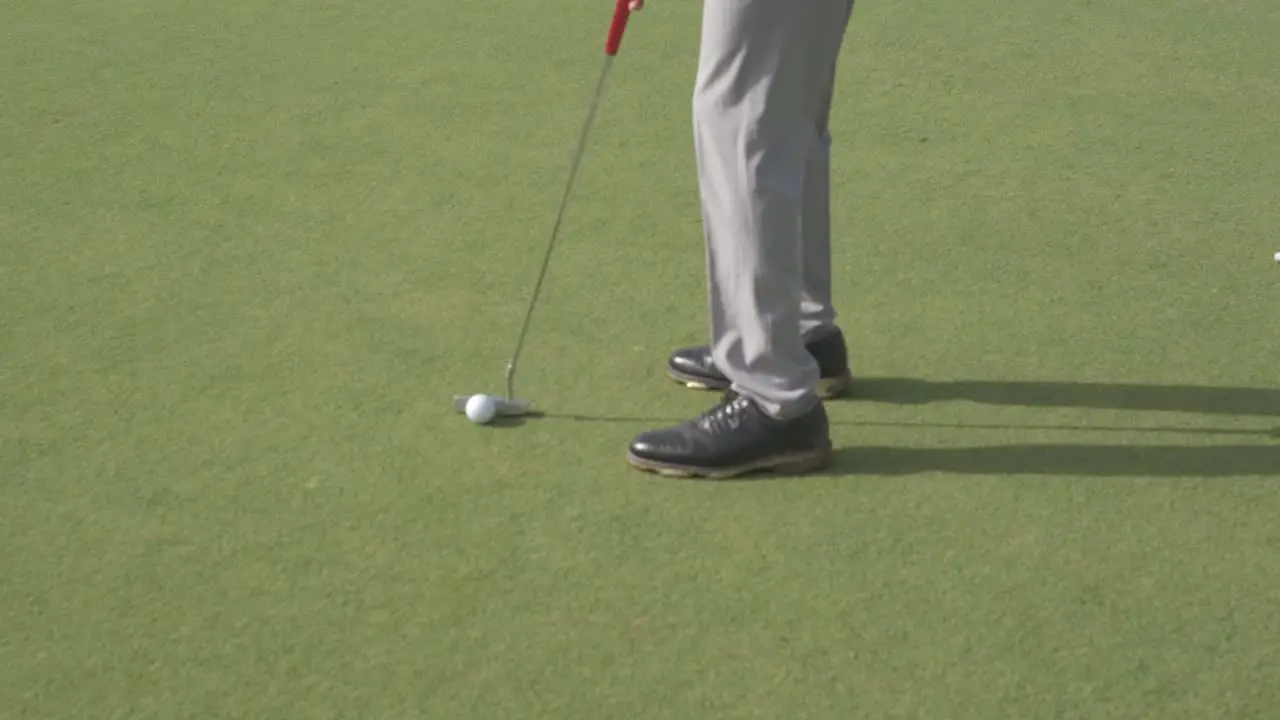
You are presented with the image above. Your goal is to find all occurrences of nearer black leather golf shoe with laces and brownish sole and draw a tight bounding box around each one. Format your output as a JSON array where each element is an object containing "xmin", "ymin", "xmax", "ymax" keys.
[{"xmin": 627, "ymin": 391, "xmax": 831, "ymax": 478}]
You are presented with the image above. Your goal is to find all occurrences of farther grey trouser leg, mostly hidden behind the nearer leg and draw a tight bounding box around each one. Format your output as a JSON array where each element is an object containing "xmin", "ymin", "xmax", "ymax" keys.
[{"xmin": 800, "ymin": 0, "xmax": 854, "ymax": 341}]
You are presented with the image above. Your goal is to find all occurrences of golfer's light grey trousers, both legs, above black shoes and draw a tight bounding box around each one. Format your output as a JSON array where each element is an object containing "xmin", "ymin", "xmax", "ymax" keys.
[{"xmin": 694, "ymin": 0, "xmax": 854, "ymax": 418}]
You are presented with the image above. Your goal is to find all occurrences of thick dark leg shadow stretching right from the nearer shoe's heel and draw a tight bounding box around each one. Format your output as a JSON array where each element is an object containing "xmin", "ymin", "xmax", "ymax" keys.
[{"xmin": 822, "ymin": 445, "xmax": 1280, "ymax": 478}]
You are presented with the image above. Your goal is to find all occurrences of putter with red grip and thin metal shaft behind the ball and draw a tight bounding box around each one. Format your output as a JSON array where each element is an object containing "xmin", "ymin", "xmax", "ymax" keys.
[{"xmin": 453, "ymin": 0, "xmax": 631, "ymax": 418}]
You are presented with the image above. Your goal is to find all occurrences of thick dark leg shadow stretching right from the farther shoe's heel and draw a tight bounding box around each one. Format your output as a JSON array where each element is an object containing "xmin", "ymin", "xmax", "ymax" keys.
[{"xmin": 852, "ymin": 377, "xmax": 1280, "ymax": 418}]
